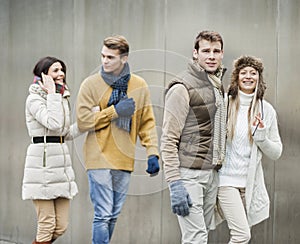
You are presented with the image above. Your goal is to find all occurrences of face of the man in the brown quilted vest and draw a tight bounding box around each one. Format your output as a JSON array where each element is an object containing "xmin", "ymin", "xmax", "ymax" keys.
[{"xmin": 193, "ymin": 39, "xmax": 223, "ymax": 73}]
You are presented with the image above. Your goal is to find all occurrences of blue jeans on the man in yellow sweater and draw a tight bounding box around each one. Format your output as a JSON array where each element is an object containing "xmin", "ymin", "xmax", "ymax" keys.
[{"xmin": 88, "ymin": 169, "xmax": 131, "ymax": 244}]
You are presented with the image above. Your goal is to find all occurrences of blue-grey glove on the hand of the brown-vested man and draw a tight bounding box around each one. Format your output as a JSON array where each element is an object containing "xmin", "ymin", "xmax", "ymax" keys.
[{"xmin": 169, "ymin": 180, "xmax": 193, "ymax": 216}]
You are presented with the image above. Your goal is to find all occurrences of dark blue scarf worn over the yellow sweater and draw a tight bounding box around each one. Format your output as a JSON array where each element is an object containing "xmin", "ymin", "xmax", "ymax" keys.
[{"xmin": 101, "ymin": 63, "xmax": 131, "ymax": 132}]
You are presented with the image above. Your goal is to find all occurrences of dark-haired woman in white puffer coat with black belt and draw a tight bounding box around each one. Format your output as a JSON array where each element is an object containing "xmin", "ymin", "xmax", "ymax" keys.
[{"xmin": 22, "ymin": 57, "xmax": 80, "ymax": 244}]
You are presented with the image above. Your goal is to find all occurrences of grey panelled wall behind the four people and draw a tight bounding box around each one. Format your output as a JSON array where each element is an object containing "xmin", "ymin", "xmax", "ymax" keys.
[{"xmin": 0, "ymin": 0, "xmax": 300, "ymax": 244}]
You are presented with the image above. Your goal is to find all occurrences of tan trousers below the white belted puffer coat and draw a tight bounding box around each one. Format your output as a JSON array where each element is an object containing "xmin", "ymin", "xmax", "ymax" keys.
[{"xmin": 33, "ymin": 198, "xmax": 70, "ymax": 242}]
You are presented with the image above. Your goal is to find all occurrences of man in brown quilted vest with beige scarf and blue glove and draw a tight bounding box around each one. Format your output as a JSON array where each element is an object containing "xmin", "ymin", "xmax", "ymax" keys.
[{"xmin": 161, "ymin": 31, "xmax": 226, "ymax": 244}]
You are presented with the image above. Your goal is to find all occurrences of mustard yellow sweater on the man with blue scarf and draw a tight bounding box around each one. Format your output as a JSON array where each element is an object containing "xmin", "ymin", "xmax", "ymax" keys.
[{"xmin": 76, "ymin": 73, "xmax": 159, "ymax": 171}]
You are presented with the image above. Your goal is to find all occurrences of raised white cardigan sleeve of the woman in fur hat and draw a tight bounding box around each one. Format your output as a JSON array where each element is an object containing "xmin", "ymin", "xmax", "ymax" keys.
[{"xmin": 253, "ymin": 103, "xmax": 282, "ymax": 160}]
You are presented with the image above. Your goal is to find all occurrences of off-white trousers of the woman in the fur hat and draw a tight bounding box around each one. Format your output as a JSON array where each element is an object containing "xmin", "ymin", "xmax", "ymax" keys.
[{"xmin": 218, "ymin": 186, "xmax": 251, "ymax": 244}]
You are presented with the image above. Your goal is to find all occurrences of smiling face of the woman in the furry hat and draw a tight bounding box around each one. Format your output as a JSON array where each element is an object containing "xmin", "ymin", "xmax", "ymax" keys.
[{"xmin": 238, "ymin": 66, "xmax": 259, "ymax": 94}]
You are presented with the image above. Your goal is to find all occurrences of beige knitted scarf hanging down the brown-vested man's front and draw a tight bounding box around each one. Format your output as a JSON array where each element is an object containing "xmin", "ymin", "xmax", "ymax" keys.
[{"xmin": 209, "ymin": 68, "xmax": 227, "ymax": 168}]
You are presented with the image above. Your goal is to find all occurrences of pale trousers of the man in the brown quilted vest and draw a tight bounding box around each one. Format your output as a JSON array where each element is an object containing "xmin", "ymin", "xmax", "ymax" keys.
[{"xmin": 177, "ymin": 168, "xmax": 219, "ymax": 244}]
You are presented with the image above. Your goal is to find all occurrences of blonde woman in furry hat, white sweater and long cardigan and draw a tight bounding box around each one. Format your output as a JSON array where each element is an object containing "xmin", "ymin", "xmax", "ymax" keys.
[{"xmin": 218, "ymin": 56, "xmax": 282, "ymax": 244}]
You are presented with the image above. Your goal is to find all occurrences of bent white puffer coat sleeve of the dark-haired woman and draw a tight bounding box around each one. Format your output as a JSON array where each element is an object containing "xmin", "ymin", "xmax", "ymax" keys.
[{"xmin": 26, "ymin": 93, "xmax": 64, "ymax": 130}]
